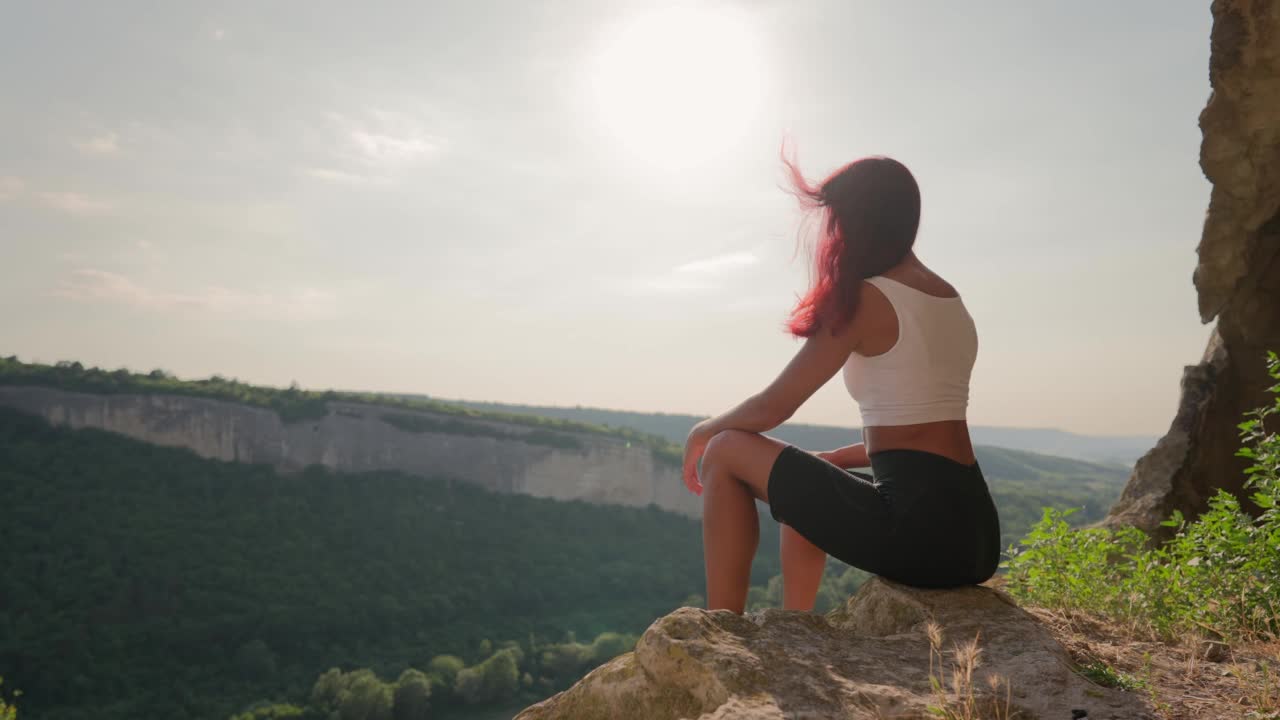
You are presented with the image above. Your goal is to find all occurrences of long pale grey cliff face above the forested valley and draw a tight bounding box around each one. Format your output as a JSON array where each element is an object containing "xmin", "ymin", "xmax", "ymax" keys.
[{"xmin": 0, "ymin": 387, "xmax": 701, "ymax": 516}]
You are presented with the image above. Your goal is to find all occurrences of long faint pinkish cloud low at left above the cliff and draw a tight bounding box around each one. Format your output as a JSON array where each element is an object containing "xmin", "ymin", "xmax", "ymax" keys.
[{"xmin": 51, "ymin": 268, "xmax": 337, "ymax": 318}]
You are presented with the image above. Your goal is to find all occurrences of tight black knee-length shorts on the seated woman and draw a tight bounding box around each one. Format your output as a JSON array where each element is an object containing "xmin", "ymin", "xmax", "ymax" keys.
[{"xmin": 768, "ymin": 445, "xmax": 1000, "ymax": 588}]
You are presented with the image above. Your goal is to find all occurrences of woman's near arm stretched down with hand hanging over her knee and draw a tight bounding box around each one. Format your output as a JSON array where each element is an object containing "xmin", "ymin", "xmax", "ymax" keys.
[{"xmin": 684, "ymin": 315, "xmax": 858, "ymax": 495}]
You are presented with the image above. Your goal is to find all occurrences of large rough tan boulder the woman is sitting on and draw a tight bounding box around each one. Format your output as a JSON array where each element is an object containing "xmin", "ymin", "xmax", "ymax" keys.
[{"xmin": 517, "ymin": 578, "xmax": 1155, "ymax": 720}]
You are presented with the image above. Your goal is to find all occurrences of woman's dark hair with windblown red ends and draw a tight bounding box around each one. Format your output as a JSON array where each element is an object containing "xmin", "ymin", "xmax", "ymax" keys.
[{"xmin": 782, "ymin": 151, "xmax": 920, "ymax": 337}]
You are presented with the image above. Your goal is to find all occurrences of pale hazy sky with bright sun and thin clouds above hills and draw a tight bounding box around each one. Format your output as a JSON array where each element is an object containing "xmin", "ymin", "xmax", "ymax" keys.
[{"xmin": 0, "ymin": 0, "xmax": 1211, "ymax": 436}]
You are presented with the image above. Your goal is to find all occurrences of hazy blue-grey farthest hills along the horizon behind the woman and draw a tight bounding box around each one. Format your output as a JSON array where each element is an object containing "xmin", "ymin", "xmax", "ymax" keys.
[{"xmin": 430, "ymin": 395, "xmax": 1157, "ymax": 468}]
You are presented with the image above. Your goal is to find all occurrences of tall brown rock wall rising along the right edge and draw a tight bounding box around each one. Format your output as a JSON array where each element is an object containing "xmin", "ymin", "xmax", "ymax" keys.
[{"xmin": 1108, "ymin": 0, "xmax": 1280, "ymax": 534}]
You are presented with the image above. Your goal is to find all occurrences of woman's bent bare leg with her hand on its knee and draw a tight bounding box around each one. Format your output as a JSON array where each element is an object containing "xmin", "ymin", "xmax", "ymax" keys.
[{"xmin": 699, "ymin": 430, "xmax": 785, "ymax": 614}]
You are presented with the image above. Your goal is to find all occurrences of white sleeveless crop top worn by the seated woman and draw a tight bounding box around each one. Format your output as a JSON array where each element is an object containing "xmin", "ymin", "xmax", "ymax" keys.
[{"xmin": 844, "ymin": 275, "xmax": 978, "ymax": 428}]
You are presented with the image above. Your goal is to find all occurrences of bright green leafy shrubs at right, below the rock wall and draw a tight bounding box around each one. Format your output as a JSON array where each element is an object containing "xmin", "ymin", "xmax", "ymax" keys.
[{"xmin": 1006, "ymin": 352, "xmax": 1280, "ymax": 638}]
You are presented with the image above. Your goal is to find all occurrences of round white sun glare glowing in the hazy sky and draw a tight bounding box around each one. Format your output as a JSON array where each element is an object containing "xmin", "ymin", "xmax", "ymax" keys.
[{"xmin": 591, "ymin": 6, "xmax": 764, "ymax": 169}]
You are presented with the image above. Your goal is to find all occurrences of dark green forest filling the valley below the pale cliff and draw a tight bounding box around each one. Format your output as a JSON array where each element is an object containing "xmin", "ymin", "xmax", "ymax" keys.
[{"xmin": 0, "ymin": 410, "xmax": 778, "ymax": 720}]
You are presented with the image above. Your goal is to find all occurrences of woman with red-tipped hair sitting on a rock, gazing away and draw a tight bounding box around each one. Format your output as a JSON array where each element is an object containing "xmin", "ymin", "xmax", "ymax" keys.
[{"xmin": 684, "ymin": 152, "xmax": 1000, "ymax": 614}]
